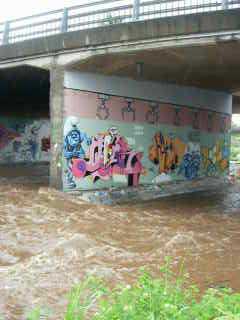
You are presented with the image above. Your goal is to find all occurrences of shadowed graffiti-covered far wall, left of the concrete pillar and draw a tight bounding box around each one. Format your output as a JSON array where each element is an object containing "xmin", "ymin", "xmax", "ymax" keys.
[{"xmin": 0, "ymin": 117, "xmax": 50, "ymax": 164}]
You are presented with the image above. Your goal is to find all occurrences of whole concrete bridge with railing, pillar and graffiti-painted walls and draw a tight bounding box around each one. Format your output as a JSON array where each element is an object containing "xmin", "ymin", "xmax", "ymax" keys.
[{"xmin": 0, "ymin": 0, "xmax": 240, "ymax": 204}]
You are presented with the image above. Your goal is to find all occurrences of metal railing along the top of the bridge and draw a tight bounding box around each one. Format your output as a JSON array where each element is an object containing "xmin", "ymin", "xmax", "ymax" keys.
[{"xmin": 0, "ymin": 0, "xmax": 240, "ymax": 45}]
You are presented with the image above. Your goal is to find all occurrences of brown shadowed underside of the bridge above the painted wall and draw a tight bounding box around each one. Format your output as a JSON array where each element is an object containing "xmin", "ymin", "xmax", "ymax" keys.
[{"xmin": 68, "ymin": 38, "xmax": 240, "ymax": 113}]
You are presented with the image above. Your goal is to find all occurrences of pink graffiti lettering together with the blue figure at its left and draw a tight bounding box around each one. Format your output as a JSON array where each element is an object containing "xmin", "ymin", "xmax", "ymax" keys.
[{"xmin": 64, "ymin": 127, "xmax": 143, "ymax": 188}]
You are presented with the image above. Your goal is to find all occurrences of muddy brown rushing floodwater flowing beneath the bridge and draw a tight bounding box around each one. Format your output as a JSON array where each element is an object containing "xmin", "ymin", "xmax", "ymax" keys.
[{"xmin": 0, "ymin": 166, "xmax": 240, "ymax": 320}]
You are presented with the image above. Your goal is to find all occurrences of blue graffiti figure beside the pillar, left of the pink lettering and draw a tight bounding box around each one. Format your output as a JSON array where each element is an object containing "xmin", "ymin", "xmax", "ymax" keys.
[{"xmin": 64, "ymin": 126, "xmax": 91, "ymax": 189}]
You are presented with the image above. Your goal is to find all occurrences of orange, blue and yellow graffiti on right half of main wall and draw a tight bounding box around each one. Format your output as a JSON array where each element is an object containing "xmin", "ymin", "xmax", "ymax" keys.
[{"xmin": 148, "ymin": 132, "xmax": 230, "ymax": 182}]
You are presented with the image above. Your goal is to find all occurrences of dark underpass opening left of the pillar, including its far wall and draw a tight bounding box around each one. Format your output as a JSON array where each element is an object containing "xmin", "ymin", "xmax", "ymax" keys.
[{"xmin": 0, "ymin": 66, "xmax": 50, "ymax": 184}]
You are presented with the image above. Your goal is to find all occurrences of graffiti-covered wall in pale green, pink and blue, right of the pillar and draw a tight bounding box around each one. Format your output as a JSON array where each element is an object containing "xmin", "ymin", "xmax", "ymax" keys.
[{"xmin": 63, "ymin": 72, "xmax": 231, "ymax": 190}]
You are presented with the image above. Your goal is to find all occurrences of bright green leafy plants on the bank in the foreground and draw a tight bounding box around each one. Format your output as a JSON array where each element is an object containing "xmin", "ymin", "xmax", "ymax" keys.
[{"xmin": 24, "ymin": 262, "xmax": 240, "ymax": 320}]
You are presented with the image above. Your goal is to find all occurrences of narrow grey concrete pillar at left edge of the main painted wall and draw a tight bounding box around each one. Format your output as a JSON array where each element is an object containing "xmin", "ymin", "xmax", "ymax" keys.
[{"xmin": 50, "ymin": 65, "xmax": 64, "ymax": 190}]
